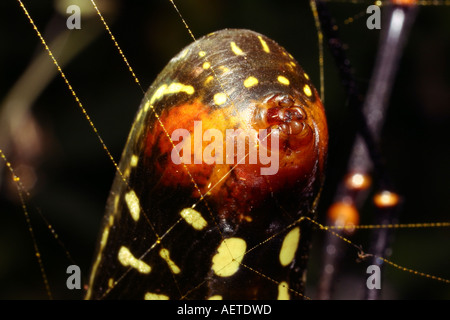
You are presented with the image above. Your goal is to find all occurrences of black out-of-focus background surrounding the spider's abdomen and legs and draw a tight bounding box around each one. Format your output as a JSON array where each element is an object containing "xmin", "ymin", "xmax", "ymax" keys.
[{"xmin": 0, "ymin": 0, "xmax": 450, "ymax": 299}]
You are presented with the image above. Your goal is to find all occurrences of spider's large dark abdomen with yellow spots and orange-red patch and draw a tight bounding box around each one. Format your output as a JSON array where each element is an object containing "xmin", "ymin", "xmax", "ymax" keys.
[{"xmin": 87, "ymin": 30, "xmax": 328, "ymax": 299}]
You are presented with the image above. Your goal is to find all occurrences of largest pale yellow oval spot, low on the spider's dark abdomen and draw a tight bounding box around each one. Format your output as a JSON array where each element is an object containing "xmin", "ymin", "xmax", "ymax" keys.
[{"xmin": 211, "ymin": 238, "xmax": 247, "ymax": 277}]
